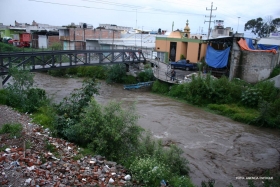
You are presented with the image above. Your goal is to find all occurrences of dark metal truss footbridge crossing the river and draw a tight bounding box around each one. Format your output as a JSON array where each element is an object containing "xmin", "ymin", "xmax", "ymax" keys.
[{"xmin": 0, "ymin": 49, "xmax": 146, "ymax": 85}]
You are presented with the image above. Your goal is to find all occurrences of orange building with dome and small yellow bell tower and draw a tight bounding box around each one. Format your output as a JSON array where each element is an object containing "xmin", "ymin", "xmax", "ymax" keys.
[{"xmin": 155, "ymin": 20, "xmax": 207, "ymax": 63}]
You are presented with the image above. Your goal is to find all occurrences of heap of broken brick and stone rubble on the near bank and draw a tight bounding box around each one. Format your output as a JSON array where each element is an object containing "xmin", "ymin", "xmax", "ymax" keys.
[{"xmin": 0, "ymin": 106, "xmax": 132, "ymax": 187}]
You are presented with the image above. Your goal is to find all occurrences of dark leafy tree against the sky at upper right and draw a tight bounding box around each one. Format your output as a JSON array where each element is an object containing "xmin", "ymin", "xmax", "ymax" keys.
[{"xmin": 244, "ymin": 16, "xmax": 280, "ymax": 38}]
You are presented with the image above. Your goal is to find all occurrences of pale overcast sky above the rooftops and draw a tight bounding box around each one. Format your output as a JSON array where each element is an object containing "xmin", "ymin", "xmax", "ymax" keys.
[{"xmin": 0, "ymin": 0, "xmax": 280, "ymax": 37}]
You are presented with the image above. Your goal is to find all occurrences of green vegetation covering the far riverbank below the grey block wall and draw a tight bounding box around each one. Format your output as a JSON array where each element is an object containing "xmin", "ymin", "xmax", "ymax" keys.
[{"xmin": 152, "ymin": 74, "xmax": 280, "ymax": 128}]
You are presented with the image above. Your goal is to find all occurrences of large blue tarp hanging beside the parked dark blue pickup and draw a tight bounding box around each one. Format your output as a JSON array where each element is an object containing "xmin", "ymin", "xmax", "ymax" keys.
[{"xmin": 205, "ymin": 45, "xmax": 230, "ymax": 68}]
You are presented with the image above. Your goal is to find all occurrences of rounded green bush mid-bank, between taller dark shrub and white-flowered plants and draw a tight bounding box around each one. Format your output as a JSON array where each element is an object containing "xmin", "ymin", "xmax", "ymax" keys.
[{"xmin": 84, "ymin": 100, "xmax": 143, "ymax": 162}]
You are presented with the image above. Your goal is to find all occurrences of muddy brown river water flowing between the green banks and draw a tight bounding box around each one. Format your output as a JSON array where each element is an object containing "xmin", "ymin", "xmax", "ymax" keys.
[{"xmin": 31, "ymin": 73, "xmax": 280, "ymax": 187}]
